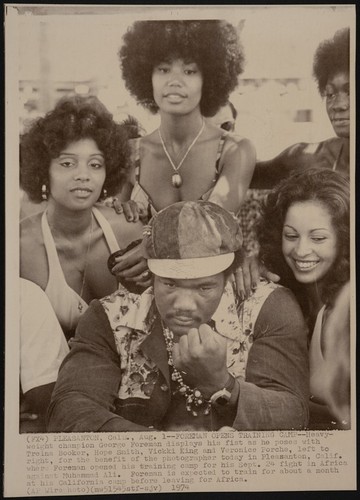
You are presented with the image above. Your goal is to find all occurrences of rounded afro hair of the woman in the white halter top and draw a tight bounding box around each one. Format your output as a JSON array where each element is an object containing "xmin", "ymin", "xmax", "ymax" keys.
[{"xmin": 20, "ymin": 96, "xmax": 130, "ymax": 203}]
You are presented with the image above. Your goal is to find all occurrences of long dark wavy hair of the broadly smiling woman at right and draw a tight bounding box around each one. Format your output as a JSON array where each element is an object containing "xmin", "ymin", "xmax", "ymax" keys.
[{"xmin": 257, "ymin": 167, "xmax": 350, "ymax": 305}]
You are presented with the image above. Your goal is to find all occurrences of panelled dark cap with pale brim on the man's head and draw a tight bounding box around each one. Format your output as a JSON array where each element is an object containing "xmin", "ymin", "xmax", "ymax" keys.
[{"xmin": 143, "ymin": 201, "xmax": 243, "ymax": 279}]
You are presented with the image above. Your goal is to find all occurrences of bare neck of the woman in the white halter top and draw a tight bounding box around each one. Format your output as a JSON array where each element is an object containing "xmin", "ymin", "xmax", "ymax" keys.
[{"xmin": 47, "ymin": 199, "xmax": 92, "ymax": 238}]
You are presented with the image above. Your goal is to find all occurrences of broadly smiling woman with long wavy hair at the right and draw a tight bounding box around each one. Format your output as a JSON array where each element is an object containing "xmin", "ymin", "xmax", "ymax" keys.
[{"xmin": 258, "ymin": 167, "xmax": 350, "ymax": 429}]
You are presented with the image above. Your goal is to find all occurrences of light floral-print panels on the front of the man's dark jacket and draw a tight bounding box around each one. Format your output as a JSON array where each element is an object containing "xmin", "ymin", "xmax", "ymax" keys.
[{"xmin": 100, "ymin": 282, "xmax": 278, "ymax": 399}]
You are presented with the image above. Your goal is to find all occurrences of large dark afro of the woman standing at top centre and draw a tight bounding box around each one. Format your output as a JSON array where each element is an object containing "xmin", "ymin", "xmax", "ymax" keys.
[{"xmin": 118, "ymin": 20, "xmax": 244, "ymax": 116}]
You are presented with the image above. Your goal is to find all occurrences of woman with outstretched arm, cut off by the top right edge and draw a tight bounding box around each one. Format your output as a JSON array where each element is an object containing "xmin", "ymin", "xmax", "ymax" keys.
[{"xmin": 251, "ymin": 28, "xmax": 350, "ymax": 189}]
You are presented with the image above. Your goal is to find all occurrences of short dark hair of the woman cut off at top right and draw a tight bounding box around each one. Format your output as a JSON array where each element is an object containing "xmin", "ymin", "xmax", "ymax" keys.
[{"xmin": 313, "ymin": 28, "xmax": 350, "ymax": 95}]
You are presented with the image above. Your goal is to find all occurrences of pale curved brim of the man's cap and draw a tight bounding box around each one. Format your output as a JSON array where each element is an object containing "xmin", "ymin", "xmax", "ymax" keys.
[{"xmin": 147, "ymin": 253, "xmax": 235, "ymax": 279}]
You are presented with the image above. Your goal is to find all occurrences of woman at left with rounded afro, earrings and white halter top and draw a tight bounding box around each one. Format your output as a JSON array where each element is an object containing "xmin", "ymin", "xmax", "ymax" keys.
[{"xmin": 20, "ymin": 96, "xmax": 142, "ymax": 338}]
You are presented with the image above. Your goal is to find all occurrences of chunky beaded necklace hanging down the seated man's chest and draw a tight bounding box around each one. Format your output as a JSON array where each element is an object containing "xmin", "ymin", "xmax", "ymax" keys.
[{"xmin": 162, "ymin": 323, "xmax": 211, "ymax": 417}]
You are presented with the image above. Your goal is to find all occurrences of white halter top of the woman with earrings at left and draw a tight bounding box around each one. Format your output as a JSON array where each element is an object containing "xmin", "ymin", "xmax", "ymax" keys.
[{"xmin": 41, "ymin": 208, "xmax": 120, "ymax": 331}]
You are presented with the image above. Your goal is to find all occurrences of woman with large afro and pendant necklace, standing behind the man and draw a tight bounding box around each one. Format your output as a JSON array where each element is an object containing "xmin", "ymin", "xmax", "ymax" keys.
[{"xmin": 109, "ymin": 20, "xmax": 255, "ymax": 296}]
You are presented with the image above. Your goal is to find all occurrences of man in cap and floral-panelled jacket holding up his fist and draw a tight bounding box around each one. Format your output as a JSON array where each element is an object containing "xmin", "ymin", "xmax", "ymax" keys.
[{"xmin": 48, "ymin": 201, "xmax": 309, "ymax": 432}]
